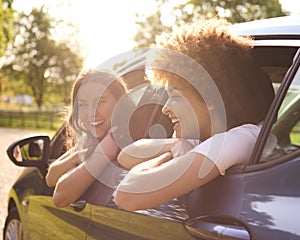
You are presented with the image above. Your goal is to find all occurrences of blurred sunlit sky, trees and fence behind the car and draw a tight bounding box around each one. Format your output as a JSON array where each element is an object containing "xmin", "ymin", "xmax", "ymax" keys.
[{"xmin": 0, "ymin": 0, "xmax": 300, "ymax": 131}]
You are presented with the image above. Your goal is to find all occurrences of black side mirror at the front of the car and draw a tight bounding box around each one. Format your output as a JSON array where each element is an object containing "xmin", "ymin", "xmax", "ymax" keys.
[{"xmin": 7, "ymin": 134, "xmax": 50, "ymax": 167}]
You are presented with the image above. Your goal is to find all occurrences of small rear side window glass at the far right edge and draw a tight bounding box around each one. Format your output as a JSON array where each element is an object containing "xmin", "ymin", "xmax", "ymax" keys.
[{"xmin": 261, "ymin": 65, "xmax": 300, "ymax": 161}]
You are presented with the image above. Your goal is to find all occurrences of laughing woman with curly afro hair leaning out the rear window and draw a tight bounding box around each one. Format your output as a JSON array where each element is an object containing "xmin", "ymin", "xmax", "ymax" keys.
[{"xmin": 114, "ymin": 19, "xmax": 274, "ymax": 211}]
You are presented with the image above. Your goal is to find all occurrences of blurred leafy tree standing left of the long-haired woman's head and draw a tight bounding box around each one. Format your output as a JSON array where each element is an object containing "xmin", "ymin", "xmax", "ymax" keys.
[{"xmin": 2, "ymin": 7, "xmax": 82, "ymax": 108}]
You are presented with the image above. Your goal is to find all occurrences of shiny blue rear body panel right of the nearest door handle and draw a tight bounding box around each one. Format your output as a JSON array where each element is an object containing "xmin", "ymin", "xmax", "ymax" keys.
[{"xmin": 240, "ymin": 157, "xmax": 300, "ymax": 239}]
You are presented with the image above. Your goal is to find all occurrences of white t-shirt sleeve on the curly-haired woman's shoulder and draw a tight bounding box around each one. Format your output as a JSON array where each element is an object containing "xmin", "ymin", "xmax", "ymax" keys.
[{"xmin": 190, "ymin": 124, "xmax": 261, "ymax": 175}]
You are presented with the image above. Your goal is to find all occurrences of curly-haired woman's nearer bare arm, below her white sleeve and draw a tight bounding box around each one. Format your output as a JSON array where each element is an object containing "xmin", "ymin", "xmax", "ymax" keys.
[{"xmin": 115, "ymin": 152, "xmax": 220, "ymax": 211}]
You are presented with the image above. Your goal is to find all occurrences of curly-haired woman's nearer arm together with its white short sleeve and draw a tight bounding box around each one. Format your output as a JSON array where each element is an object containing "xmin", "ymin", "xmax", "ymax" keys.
[{"xmin": 115, "ymin": 124, "xmax": 260, "ymax": 210}]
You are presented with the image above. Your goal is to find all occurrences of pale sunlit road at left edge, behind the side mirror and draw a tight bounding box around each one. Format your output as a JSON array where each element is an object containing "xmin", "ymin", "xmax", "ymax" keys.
[{"xmin": 0, "ymin": 128, "xmax": 44, "ymax": 238}]
